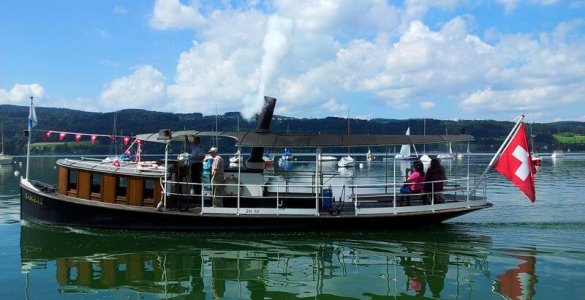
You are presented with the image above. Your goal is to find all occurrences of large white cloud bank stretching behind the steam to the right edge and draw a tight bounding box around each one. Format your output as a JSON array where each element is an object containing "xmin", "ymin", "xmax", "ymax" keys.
[{"xmin": 136, "ymin": 0, "xmax": 585, "ymax": 120}]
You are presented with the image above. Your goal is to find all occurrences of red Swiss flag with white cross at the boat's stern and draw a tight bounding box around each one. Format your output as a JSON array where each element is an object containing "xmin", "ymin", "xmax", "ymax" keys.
[{"xmin": 494, "ymin": 123, "xmax": 536, "ymax": 202}]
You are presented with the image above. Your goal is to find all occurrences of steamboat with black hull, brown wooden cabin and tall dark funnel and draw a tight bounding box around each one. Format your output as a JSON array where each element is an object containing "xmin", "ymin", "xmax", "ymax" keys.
[{"xmin": 21, "ymin": 99, "xmax": 498, "ymax": 231}]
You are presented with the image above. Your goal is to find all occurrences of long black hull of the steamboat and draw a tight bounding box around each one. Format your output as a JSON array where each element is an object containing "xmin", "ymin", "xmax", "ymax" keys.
[{"xmin": 20, "ymin": 180, "xmax": 491, "ymax": 232}]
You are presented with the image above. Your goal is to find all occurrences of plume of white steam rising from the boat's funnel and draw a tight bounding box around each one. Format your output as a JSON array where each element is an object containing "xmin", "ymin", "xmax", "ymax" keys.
[{"xmin": 242, "ymin": 15, "xmax": 293, "ymax": 118}]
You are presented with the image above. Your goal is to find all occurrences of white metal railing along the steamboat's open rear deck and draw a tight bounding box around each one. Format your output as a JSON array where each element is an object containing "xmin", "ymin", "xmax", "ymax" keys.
[{"xmin": 163, "ymin": 177, "xmax": 487, "ymax": 215}]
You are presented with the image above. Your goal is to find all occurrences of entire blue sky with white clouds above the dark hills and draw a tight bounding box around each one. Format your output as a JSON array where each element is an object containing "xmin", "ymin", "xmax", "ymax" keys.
[{"xmin": 0, "ymin": 0, "xmax": 585, "ymax": 122}]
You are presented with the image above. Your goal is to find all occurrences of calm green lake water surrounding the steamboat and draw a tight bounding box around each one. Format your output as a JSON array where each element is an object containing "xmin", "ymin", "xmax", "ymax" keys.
[{"xmin": 0, "ymin": 156, "xmax": 585, "ymax": 299}]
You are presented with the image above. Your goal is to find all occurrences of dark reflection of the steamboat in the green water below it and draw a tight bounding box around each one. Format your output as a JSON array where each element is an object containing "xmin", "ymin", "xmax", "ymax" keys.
[{"xmin": 21, "ymin": 224, "xmax": 500, "ymax": 299}]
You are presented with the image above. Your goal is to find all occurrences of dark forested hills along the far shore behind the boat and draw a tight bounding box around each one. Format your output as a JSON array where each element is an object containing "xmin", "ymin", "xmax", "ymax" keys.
[{"xmin": 0, "ymin": 105, "xmax": 585, "ymax": 155}]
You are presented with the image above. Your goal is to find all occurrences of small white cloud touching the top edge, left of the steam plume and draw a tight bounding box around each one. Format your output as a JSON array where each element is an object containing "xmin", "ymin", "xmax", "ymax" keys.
[{"xmin": 150, "ymin": 0, "xmax": 205, "ymax": 30}]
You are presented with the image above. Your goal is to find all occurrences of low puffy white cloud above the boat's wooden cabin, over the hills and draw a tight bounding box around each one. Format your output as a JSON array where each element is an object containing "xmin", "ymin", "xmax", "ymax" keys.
[{"xmin": 100, "ymin": 66, "xmax": 166, "ymax": 111}]
